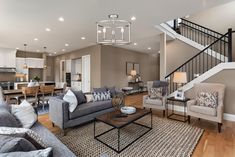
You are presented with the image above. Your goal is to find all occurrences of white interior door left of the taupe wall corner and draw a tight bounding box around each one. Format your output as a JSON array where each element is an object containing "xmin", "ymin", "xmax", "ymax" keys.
[{"xmin": 82, "ymin": 55, "xmax": 91, "ymax": 93}]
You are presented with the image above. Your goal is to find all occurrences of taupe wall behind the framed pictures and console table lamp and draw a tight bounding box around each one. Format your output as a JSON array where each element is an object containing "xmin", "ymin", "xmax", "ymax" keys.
[{"xmin": 101, "ymin": 46, "xmax": 159, "ymax": 88}]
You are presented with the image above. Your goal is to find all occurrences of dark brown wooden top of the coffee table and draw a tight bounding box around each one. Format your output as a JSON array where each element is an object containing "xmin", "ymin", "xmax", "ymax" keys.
[{"xmin": 96, "ymin": 108, "xmax": 151, "ymax": 128}]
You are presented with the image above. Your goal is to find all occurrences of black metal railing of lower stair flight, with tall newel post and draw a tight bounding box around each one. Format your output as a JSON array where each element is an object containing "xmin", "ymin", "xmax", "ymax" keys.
[{"xmin": 165, "ymin": 29, "xmax": 232, "ymax": 94}]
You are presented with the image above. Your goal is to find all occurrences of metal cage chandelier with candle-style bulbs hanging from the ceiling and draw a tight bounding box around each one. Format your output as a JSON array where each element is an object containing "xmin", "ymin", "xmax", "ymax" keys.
[{"xmin": 96, "ymin": 14, "xmax": 131, "ymax": 45}]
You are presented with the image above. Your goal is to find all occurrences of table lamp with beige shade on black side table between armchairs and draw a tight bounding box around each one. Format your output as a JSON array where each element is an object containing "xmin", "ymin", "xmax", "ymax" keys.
[{"xmin": 173, "ymin": 72, "xmax": 187, "ymax": 100}]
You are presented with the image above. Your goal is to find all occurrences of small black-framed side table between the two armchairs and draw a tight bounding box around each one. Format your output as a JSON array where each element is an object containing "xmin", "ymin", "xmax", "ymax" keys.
[{"xmin": 166, "ymin": 97, "xmax": 190, "ymax": 122}]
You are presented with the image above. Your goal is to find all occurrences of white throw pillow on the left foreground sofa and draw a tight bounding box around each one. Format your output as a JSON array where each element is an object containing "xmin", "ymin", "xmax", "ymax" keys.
[{"xmin": 11, "ymin": 100, "xmax": 38, "ymax": 128}]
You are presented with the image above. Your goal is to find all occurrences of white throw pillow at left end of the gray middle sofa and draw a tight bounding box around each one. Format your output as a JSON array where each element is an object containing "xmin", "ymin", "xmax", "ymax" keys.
[{"xmin": 63, "ymin": 90, "xmax": 78, "ymax": 112}]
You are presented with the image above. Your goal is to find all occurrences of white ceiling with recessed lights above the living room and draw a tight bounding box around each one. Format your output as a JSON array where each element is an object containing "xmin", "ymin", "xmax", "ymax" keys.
[{"xmin": 0, "ymin": 0, "xmax": 232, "ymax": 55}]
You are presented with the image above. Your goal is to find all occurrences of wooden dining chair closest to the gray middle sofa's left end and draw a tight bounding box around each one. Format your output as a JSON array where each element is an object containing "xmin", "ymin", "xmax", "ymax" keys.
[{"xmin": 39, "ymin": 85, "xmax": 55, "ymax": 110}]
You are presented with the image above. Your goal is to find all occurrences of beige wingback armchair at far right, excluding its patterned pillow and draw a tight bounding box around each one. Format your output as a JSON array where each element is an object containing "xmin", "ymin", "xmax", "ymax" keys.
[{"xmin": 187, "ymin": 83, "xmax": 225, "ymax": 132}]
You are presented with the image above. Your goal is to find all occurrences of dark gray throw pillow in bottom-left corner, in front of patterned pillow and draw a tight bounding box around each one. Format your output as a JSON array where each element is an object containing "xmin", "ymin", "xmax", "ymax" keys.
[{"xmin": 0, "ymin": 135, "xmax": 36, "ymax": 153}]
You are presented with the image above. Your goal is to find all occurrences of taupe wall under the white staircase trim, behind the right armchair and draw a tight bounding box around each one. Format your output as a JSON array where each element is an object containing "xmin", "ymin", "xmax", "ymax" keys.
[{"xmin": 186, "ymin": 70, "xmax": 235, "ymax": 114}]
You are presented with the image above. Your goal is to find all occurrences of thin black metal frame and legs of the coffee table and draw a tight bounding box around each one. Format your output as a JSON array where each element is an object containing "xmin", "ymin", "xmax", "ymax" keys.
[{"xmin": 94, "ymin": 110, "xmax": 153, "ymax": 153}]
